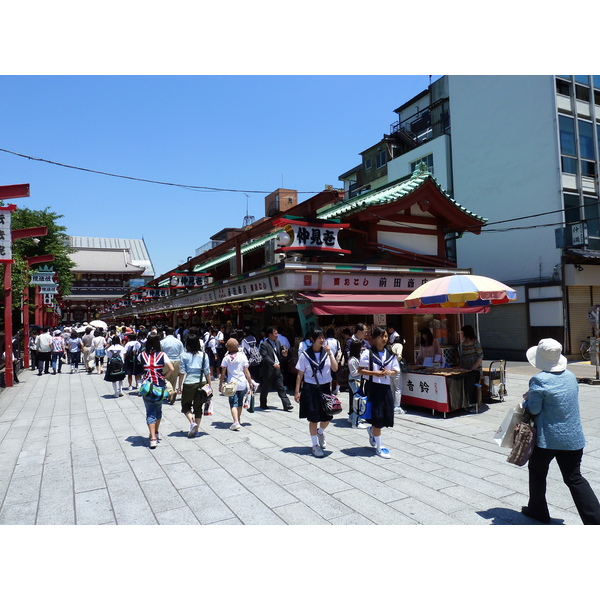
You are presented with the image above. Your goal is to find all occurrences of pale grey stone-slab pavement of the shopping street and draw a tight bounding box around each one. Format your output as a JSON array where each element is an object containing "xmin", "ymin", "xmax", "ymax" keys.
[{"xmin": 0, "ymin": 363, "xmax": 600, "ymax": 525}]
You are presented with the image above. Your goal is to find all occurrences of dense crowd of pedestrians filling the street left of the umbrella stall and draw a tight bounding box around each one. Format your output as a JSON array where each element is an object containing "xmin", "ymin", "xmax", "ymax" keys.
[{"xmin": 24, "ymin": 323, "xmax": 404, "ymax": 458}]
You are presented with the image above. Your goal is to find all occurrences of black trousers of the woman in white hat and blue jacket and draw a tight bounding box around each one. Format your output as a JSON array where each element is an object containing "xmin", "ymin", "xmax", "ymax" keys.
[{"xmin": 528, "ymin": 446, "xmax": 600, "ymax": 525}]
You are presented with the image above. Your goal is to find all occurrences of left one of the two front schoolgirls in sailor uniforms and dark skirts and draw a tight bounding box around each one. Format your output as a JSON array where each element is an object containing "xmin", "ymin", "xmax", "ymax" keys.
[{"xmin": 294, "ymin": 329, "xmax": 338, "ymax": 457}]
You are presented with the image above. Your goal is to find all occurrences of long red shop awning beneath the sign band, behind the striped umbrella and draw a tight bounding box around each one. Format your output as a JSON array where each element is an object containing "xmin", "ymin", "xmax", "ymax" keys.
[{"xmin": 298, "ymin": 292, "xmax": 490, "ymax": 315}]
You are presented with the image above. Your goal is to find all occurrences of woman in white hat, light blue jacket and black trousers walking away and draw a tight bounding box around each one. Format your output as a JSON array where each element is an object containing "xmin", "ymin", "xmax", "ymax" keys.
[{"xmin": 521, "ymin": 338, "xmax": 600, "ymax": 525}]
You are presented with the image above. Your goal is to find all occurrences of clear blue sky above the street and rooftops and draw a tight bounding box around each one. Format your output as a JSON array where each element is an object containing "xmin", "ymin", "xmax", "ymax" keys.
[{"xmin": 0, "ymin": 75, "xmax": 436, "ymax": 275}]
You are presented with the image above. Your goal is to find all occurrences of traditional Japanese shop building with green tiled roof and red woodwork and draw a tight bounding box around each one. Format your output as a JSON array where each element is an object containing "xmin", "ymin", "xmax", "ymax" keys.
[{"xmin": 105, "ymin": 164, "xmax": 486, "ymax": 356}]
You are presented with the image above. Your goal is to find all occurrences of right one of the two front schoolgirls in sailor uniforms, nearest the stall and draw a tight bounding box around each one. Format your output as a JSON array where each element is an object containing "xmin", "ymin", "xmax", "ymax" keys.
[{"xmin": 358, "ymin": 327, "xmax": 400, "ymax": 458}]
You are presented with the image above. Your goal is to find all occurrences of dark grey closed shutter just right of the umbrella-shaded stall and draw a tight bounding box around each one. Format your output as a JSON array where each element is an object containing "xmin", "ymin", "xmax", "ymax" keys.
[{"xmin": 479, "ymin": 303, "xmax": 529, "ymax": 351}]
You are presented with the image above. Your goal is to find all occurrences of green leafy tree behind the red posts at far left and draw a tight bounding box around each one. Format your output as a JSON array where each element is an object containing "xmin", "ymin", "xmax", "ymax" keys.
[{"xmin": 12, "ymin": 207, "xmax": 75, "ymax": 307}]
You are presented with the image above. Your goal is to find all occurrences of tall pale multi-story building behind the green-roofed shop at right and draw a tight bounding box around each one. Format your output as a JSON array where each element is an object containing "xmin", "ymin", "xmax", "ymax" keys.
[{"xmin": 340, "ymin": 75, "xmax": 600, "ymax": 358}]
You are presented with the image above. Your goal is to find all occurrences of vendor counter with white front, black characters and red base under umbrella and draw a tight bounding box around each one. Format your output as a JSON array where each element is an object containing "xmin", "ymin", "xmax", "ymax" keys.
[{"xmin": 402, "ymin": 365, "xmax": 480, "ymax": 415}]
